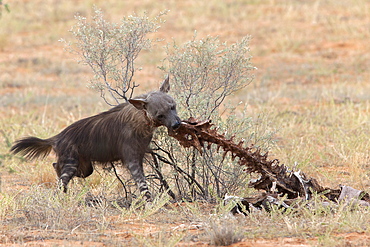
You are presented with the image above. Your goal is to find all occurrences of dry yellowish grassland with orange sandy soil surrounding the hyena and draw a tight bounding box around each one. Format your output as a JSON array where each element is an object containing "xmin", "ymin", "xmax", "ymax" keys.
[{"xmin": 0, "ymin": 0, "xmax": 370, "ymax": 246}]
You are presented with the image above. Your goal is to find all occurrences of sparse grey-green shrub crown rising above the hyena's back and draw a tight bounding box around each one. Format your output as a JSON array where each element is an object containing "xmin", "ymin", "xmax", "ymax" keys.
[{"xmin": 62, "ymin": 9, "xmax": 164, "ymax": 105}]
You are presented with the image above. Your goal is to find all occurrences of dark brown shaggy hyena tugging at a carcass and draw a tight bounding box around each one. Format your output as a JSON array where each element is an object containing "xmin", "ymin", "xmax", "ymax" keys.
[{"xmin": 11, "ymin": 77, "xmax": 181, "ymax": 200}]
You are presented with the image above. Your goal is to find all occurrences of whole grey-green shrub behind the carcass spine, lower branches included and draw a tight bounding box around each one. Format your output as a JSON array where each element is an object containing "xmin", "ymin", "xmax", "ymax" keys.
[{"xmin": 150, "ymin": 34, "xmax": 271, "ymax": 201}]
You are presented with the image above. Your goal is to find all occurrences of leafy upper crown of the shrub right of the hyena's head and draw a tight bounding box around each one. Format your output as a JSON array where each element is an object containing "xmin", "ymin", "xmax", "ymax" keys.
[{"xmin": 162, "ymin": 35, "xmax": 255, "ymax": 119}]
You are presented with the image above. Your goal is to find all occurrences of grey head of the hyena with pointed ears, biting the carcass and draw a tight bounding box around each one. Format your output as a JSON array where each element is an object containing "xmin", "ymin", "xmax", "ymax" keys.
[{"xmin": 129, "ymin": 77, "xmax": 181, "ymax": 131}]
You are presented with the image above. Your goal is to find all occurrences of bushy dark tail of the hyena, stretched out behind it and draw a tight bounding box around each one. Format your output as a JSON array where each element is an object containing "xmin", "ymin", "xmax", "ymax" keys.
[{"xmin": 10, "ymin": 137, "xmax": 52, "ymax": 159}]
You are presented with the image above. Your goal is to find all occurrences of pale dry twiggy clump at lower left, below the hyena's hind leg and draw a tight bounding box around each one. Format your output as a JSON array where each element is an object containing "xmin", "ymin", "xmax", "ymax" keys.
[{"xmin": 15, "ymin": 186, "xmax": 107, "ymax": 231}]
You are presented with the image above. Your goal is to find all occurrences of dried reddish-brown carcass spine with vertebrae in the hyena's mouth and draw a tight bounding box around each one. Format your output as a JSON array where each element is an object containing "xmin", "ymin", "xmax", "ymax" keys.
[{"xmin": 170, "ymin": 118, "xmax": 340, "ymax": 200}]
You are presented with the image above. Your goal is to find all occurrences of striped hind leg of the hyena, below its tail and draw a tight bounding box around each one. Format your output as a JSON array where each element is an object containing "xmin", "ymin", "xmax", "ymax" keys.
[{"xmin": 56, "ymin": 158, "xmax": 78, "ymax": 192}]
